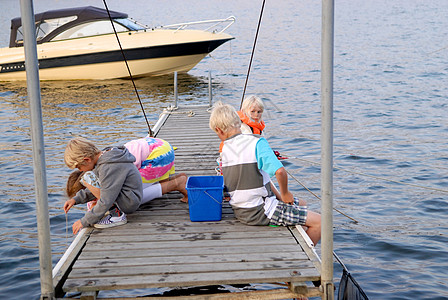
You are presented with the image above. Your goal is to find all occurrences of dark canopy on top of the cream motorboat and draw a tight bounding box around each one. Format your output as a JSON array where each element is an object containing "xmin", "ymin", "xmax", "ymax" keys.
[{"xmin": 9, "ymin": 6, "xmax": 128, "ymax": 48}]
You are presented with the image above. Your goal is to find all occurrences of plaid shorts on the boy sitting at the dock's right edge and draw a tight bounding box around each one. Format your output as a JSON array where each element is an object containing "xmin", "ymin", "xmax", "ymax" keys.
[{"xmin": 269, "ymin": 198, "xmax": 308, "ymax": 226}]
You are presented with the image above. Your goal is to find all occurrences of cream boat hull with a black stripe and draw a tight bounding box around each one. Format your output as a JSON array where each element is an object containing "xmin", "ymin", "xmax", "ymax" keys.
[{"xmin": 0, "ymin": 30, "xmax": 232, "ymax": 81}]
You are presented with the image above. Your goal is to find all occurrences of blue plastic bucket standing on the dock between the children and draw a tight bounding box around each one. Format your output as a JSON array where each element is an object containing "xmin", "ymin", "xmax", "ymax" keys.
[{"xmin": 186, "ymin": 176, "xmax": 224, "ymax": 222}]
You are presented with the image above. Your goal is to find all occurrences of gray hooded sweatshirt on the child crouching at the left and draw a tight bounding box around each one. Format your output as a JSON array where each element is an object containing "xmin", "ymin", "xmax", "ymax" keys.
[{"xmin": 73, "ymin": 146, "xmax": 143, "ymax": 227}]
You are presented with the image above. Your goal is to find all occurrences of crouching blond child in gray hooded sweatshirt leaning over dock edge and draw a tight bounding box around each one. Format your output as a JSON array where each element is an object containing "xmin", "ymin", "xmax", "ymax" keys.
[{"xmin": 64, "ymin": 137, "xmax": 143, "ymax": 234}]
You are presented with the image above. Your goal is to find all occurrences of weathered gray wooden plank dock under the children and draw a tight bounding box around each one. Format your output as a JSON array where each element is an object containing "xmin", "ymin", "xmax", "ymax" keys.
[{"xmin": 53, "ymin": 106, "xmax": 322, "ymax": 299}]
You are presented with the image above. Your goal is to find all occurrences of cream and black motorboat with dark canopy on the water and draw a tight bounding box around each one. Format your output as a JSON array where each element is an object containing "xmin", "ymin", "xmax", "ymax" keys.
[{"xmin": 0, "ymin": 6, "xmax": 235, "ymax": 81}]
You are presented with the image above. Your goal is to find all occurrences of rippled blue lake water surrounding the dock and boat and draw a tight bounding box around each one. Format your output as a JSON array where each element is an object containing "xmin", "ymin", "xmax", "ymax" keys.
[{"xmin": 0, "ymin": 0, "xmax": 448, "ymax": 299}]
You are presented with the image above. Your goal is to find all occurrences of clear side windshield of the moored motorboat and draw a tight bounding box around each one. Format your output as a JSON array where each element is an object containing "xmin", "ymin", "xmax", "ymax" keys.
[{"xmin": 51, "ymin": 20, "xmax": 133, "ymax": 41}]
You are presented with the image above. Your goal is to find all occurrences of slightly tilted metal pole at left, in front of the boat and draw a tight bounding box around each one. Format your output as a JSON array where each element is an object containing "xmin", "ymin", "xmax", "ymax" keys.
[{"xmin": 20, "ymin": 0, "xmax": 54, "ymax": 299}]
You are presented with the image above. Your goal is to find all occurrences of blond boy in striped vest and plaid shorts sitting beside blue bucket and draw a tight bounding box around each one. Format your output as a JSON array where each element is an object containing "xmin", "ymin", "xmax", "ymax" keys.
[{"xmin": 209, "ymin": 102, "xmax": 321, "ymax": 245}]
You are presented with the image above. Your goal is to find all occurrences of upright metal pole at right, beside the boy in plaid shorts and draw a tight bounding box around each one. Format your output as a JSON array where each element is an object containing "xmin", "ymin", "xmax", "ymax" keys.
[{"xmin": 321, "ymin": 0, "xmax": 334, "ymax": 300}]
